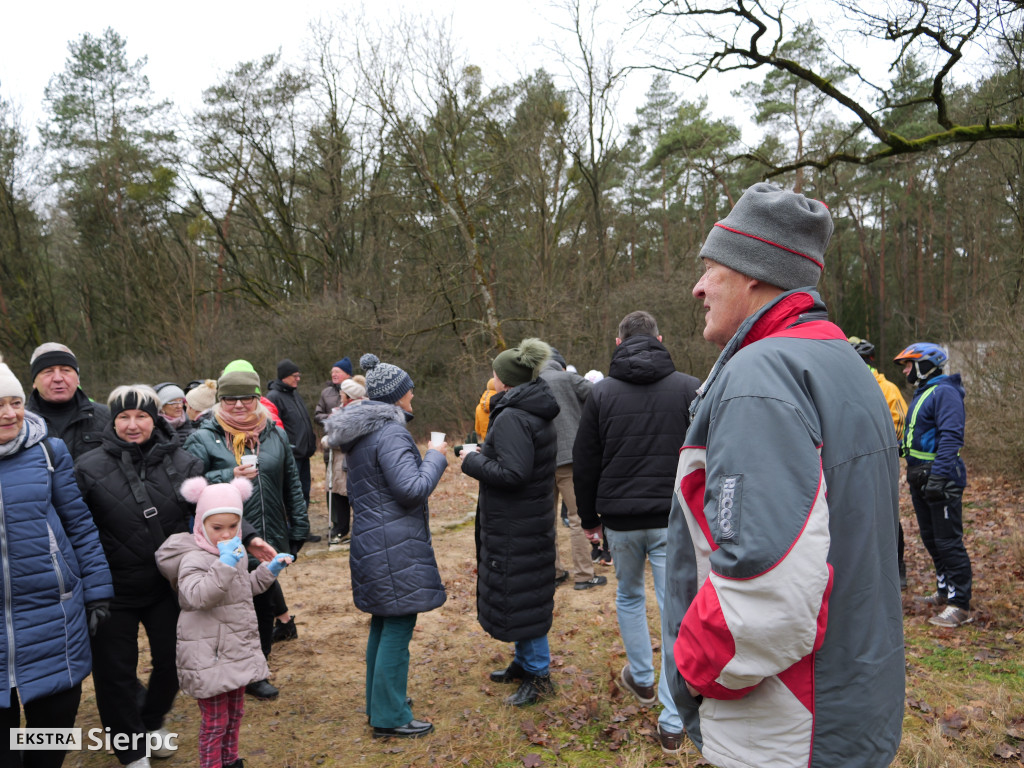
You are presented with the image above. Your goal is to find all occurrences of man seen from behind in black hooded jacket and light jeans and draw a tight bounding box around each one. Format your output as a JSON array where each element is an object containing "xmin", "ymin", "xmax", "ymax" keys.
[{"xmin": 572, "ymin": 311, "xmax": 699, "ymax": 754}]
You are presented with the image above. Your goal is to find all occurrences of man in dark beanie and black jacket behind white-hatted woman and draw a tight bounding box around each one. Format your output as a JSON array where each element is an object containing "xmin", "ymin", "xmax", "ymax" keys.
[{"xmin": 26, "ymin": 341, "xmax": 111, "ymax": 459}]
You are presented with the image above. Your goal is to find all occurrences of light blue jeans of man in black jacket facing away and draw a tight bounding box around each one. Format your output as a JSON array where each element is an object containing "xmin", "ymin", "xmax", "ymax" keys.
[{"xmin": 604, "ymin": 527, "xmax": 683, "ymax": 733}]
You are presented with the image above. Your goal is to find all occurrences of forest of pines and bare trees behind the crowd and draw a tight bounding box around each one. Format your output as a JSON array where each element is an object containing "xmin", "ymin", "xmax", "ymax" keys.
[{"xmin": 0, "ymin": 0, "xmax": 1024, "ymax": 476}]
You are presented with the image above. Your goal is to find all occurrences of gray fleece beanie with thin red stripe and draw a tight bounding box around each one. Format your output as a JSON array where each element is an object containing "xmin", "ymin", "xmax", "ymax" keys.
[{"xmin": 699, "ymin": 181, "xmax": 834, "ymax": 291}]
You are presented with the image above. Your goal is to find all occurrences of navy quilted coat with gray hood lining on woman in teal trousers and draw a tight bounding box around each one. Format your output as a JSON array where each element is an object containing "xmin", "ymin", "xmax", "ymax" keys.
[{"xmin": 327, "ymin": 400, "xmax": 447, "ymax": 616}]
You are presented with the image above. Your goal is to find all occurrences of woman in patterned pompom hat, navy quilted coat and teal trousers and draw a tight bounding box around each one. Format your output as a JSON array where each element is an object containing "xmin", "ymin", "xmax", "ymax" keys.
[{"xmin": 327, "ymin": 354, "xmax": 447, "ymax": 738}]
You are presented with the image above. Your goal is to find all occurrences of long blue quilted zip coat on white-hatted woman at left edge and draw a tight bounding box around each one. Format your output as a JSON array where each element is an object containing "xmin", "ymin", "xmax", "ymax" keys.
[{"xmin": 0, "ymin": 412, "xmax": 114, "ymax": 709}]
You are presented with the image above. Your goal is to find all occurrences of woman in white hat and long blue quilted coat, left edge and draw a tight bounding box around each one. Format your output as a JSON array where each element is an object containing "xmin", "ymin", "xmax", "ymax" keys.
[{"xmin": 0, "ymin": 358, "xmax": 114, "ymax": 768}]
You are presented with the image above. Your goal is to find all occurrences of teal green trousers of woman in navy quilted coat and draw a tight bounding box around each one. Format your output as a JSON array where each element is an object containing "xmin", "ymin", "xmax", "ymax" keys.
[{"xmin": 367, "ymin": 613, "xmax": 418, "ymax": 728}]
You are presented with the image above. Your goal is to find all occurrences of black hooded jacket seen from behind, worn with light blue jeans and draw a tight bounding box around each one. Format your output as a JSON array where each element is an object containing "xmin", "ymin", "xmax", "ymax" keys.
[{"xmin": 572, "ymin": 336, "xmax": 700, "ymax": 530}]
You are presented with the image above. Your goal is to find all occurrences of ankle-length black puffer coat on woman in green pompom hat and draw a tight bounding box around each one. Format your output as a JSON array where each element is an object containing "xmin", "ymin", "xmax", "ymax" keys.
[{"xmin": 462, "ymin": 379, "xmax": 558, "ymax": 642}]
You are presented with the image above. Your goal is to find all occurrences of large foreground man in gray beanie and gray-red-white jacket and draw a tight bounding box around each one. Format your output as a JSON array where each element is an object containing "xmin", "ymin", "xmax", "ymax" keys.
[{"xmin": 663, "ymin": 183, "xmax": 904, "ymax": 768}]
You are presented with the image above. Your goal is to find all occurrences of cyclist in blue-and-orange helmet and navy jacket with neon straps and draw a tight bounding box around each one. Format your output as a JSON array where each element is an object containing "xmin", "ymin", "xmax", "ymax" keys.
[{"xmin": 893, "ymin": 342, "xmax": 972, "ymax": 628}]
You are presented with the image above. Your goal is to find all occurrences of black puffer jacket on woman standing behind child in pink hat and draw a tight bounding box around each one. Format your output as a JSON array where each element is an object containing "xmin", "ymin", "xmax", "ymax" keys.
[{"xmin": 75, "ymin": 419, "xmax": 203, "ymax": 607}]
